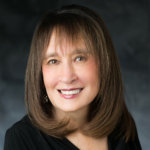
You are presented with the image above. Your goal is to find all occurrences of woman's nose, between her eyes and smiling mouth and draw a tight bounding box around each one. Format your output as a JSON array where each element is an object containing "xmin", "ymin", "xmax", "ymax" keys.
[{"xmin": 60, "ymin": 62, "xmax": 77, "ymax": 84}]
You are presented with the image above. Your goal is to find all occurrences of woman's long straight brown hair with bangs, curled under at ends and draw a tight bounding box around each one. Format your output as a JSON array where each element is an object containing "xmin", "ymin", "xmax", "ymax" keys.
[{"xmin": 25, "ymin": 5, "xmax": 135, "ymax": 141}]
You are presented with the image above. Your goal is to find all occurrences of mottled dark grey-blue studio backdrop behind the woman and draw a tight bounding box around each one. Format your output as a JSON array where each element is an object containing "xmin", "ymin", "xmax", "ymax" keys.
[{"xmin": 0, "ymin": 0, "xmax": 150, "ymax": 150}]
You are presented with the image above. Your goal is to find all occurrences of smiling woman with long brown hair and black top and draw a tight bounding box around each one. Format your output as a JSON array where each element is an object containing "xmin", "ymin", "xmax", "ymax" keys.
[{"xmin": 4, "ymin": 5, "xmax": 141, "ymax": 150}]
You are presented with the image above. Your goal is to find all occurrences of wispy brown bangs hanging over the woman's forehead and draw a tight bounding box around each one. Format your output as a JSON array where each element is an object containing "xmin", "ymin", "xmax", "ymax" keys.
[{"xmin": 49, "ymin": 16, "xmax": 94, "ymax": 54}]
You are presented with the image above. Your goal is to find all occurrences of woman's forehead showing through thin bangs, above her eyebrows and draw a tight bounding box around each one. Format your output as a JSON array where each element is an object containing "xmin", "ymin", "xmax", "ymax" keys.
[{"xmin": 46, "ymin": 30, "xmax": 89, "ymax": 55}]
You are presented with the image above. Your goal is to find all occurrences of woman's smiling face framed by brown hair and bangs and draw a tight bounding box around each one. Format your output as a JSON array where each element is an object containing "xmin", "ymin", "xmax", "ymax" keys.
[{"xmin": 42, "ymin": 33, "xmax": 99, "ymax": 112}]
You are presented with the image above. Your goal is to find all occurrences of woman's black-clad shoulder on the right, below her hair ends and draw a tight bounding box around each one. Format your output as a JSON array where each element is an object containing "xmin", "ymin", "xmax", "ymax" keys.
[{"xmin": 108, "ymin": 115, "xmax": 142, "ymax": 150}]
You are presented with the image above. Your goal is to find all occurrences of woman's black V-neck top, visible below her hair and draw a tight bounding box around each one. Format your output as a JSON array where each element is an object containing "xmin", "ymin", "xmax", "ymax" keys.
[{"xmin": 4, "ymin": 116, "xmax": 141, "ymax": 150}]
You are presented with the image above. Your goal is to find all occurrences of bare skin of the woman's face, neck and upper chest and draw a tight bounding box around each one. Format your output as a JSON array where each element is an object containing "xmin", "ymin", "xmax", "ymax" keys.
[{"xmin": 42, "ymin": 32, "xmax": 108, "ymax": 150}]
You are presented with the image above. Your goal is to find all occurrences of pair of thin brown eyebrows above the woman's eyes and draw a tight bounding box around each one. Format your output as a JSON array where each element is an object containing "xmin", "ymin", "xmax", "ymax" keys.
[{"xmin": 45, "ymin": 49, "xmax": 91, "ymax": 58}]
